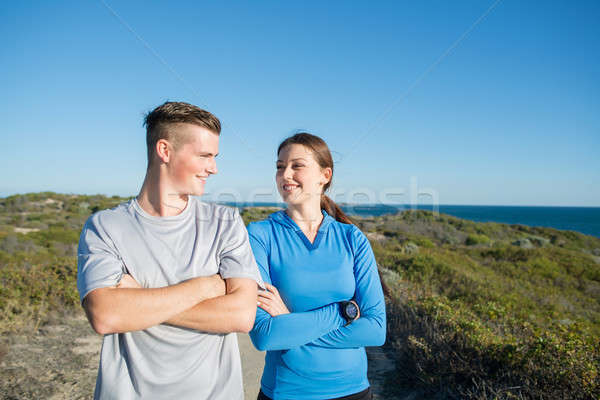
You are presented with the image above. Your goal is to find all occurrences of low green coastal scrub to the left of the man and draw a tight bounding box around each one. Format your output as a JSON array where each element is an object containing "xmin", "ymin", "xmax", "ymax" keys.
[{"xmin": 0, "ymin": 192, "xmax": 126, "ymax": 335}]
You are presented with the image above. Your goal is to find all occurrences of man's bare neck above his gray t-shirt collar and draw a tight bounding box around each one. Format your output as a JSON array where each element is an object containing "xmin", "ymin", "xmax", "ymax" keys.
[{"xmin": 137, "ymin": 171, "xmax": 189, "ymax": 217}]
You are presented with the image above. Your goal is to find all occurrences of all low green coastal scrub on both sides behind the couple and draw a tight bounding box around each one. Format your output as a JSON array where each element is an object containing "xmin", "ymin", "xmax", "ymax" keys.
[{"xmin": 0, "ymin": 192, "xmax": 600, "ymax": 399}]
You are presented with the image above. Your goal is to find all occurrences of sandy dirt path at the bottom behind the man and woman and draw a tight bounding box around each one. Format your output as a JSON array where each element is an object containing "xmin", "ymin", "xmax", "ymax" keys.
[{"xmin": 0, "ymin": 312, "xmax": 404, "ymax": 400}]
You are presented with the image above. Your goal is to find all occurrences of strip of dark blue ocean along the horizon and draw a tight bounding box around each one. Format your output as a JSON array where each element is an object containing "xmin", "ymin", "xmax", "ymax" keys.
[{"xmin": 228, "ymin": 203, "xmax": 600, "ymax": 237}]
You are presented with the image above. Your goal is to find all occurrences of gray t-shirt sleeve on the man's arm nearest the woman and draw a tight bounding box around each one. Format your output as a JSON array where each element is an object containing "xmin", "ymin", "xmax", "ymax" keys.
[{"xmin": 219, "ymin": 209, "xmax": 264, "ymax": 288}]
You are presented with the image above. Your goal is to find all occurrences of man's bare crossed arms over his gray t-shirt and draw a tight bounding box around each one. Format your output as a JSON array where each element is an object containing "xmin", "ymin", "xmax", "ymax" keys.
[{"xmin": 83, "ymin": 274, "xmax": 257, "ymax": 334}]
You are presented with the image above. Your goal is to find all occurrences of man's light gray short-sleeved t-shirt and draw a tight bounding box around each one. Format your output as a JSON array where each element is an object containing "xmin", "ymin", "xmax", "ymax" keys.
[{"xmin": 77, "ymin": 196, "xmax": 262, "ymax": 400}]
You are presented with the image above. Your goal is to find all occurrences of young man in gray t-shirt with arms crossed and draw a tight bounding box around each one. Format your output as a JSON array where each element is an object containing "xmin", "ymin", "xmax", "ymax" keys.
[{"xmin": 77, "ymin": 102, "xmax": 262, "ymax": 400}]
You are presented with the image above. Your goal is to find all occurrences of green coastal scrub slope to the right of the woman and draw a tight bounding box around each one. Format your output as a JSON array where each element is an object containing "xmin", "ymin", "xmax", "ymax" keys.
[{"xmin": 357, "ymin": 211, "xmax": 600, "ymax": 399}]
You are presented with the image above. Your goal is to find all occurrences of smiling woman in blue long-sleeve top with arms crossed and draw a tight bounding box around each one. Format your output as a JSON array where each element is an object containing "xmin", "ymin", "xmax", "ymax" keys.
[{"xmin": 248, "ymin": 133, "xmax": 386, "ymax": 400}]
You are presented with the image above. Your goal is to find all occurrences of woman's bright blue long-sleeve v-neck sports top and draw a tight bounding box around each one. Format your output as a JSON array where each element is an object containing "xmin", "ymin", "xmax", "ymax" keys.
[{"xmin": 248, "ymin": 211, "xmax": 386, "ymax": 400}]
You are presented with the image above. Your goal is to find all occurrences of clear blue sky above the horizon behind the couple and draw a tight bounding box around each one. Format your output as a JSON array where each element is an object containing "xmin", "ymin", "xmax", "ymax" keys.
[{"xmin": 0, "ymin": 0, "xmax": 600, "ymax": 206}]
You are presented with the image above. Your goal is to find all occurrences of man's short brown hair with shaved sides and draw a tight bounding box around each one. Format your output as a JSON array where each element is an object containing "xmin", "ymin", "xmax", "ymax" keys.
[{"xmin": 144, "ymin": 101, "xmax": 221, "ymax": 166}]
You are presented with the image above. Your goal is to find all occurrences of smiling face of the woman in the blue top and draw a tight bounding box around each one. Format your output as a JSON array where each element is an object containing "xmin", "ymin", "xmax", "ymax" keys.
[{"xmin": 275, "ymin": 144, "xmax": 332, "ymax": 204}]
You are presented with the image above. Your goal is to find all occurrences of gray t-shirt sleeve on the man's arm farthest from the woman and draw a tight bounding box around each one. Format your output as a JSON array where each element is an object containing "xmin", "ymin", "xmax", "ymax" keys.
[{"xmin": 77, "ymin": 215, "xmax": 123, "ymax": 304}]
